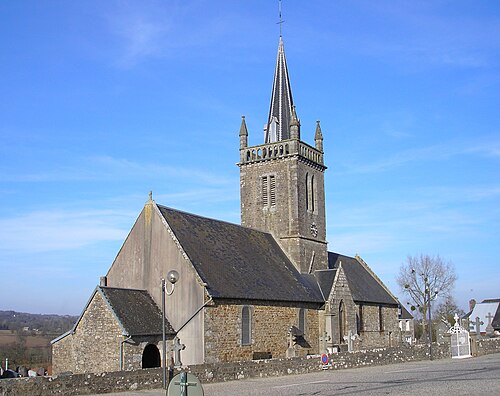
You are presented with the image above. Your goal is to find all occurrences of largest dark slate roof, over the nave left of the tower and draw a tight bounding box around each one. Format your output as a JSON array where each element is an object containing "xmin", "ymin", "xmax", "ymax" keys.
[{"xmin": 158, "ymin": 205, "xmax": 324, "ymax": 306}]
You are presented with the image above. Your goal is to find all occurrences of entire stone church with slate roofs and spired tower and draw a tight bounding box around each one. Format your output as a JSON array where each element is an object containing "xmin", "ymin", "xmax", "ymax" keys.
[{"xmin": 52, "ymin": 37, "xmax": 401, "ymax": 373}]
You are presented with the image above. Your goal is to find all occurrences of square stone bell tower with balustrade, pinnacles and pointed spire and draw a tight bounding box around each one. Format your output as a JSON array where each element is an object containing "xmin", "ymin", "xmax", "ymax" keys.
[{"xmin": 238, "ymin": 36, "xmax": 328, "ymax": 273}]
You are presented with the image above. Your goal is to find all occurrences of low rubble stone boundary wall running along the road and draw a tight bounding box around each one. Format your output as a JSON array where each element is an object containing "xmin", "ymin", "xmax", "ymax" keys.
[{"xmin": 0, "ymin": 339, "xmax": 500, "ymax": 396}]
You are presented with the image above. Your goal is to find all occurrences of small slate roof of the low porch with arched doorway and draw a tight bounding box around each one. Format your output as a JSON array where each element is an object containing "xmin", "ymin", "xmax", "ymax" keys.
[{"xmin": 97, "ymin": 286, "xmax": 175, "ymax": 336}]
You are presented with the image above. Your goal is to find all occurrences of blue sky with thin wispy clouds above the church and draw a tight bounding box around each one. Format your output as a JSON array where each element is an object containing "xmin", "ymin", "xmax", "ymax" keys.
[{"xmin": 0, "ymin": 0, "xmax": 500, "ymax": 314}]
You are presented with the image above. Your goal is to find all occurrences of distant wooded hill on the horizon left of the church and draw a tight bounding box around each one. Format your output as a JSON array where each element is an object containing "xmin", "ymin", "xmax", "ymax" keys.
[{"xmin": 0, "ymin": 311, "xmax": 78, "ymax": 335}]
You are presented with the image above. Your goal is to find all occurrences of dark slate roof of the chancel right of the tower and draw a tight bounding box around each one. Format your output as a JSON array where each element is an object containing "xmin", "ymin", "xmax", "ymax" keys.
[{"xmin": 328, "ymin": 252, "xmax": 398, "ymax": 305}]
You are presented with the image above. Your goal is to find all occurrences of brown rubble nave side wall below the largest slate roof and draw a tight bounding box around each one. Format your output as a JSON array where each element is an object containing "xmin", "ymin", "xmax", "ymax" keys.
[{"xmin": 205, "ymin": 303, "xmax": 319, "ymax": 363}]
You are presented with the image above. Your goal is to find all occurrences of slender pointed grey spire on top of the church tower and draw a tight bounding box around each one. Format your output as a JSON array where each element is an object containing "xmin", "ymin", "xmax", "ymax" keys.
[{"xmin": 264, "ymin": 36, "xmax": 293, "ymax": 143}]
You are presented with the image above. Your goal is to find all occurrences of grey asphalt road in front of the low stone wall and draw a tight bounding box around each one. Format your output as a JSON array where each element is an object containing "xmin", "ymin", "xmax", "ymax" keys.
[{"xmin": 97, "ymin": 353, "xmax": 500, "ymax": 396}]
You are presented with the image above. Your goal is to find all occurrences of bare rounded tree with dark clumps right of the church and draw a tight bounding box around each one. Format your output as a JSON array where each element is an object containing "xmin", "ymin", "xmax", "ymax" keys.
[{"xmin": 396, "ymin": 255, "xmax": 457, "ymax": 340}]
